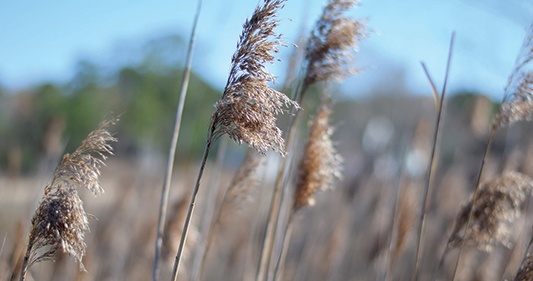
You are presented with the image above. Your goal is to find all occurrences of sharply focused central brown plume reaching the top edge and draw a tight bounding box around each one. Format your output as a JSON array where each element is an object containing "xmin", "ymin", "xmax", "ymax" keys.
[{"xmin": 212, "ymin": 0, "xmax": 299, "ymax": 155}]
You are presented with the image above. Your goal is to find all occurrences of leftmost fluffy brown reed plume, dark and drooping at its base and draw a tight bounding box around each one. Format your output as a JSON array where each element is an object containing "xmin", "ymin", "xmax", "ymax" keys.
[{"xmin": 21, "ymin": 116, "xmax": 118, "ymax": 280}]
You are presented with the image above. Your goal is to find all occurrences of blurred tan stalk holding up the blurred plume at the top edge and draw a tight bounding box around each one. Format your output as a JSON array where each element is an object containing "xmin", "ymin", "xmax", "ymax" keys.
[{"xmin": 255, "ymin": 81, "xmax": 307, "ymax": 281}]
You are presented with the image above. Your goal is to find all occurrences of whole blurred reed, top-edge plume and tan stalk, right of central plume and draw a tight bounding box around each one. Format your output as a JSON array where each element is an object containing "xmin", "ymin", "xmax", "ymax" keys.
[{"xmin": 255, "ymin": 0, "xmax": 366, "ymax": 281}]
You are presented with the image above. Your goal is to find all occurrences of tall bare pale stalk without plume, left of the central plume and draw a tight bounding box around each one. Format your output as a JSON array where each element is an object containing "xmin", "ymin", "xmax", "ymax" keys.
[{"xmin": 152, "ymin": 0, "xmax": 202, "ymax": 281}]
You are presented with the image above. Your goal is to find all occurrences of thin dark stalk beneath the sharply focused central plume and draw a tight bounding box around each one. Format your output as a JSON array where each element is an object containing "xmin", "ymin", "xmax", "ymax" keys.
[{"xmin": 172, "ymin": 122, "xmax": 216, "ymax": 281}]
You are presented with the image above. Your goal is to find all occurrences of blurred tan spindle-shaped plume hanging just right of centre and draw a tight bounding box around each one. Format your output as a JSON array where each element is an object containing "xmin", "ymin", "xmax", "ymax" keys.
[{"xmin": 293, "ymin": 98, "xmax": 342, "ymax": 212}]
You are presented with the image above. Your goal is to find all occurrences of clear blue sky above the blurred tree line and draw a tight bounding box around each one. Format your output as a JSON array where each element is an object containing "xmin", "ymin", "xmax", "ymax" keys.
[{"xmin": 0, "ymin": 0, "xmax": 533, "ymax": 99}]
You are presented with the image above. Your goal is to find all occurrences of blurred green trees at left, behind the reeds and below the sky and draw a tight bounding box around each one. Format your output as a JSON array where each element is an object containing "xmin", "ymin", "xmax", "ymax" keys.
[{"xmin": 0, "ymin": 33, "xmax": 220, "ymax": 172}]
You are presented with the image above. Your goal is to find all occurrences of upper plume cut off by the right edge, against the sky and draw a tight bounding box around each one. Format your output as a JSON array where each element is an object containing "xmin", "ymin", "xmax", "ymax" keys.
[{"xmin": 493, "ymin": 24, "xmax": 533, "ymax": 129}]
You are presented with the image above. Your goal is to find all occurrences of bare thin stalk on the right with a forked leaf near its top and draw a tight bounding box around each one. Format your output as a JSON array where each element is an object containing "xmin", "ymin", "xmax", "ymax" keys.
[{"xmin": 413, "ymin": 33, "xmax": 455, "ymax": 281}]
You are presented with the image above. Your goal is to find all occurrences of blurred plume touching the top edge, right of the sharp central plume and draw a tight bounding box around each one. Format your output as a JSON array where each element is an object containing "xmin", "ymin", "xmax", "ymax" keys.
[{"xmin": 303, "ymin": 0, "xmax": 366, "ymax": 88}]
